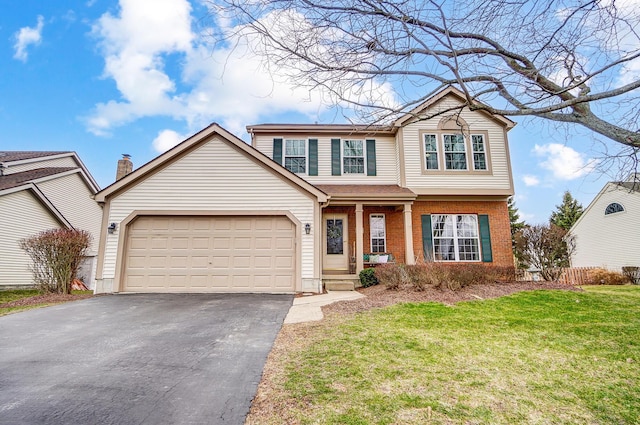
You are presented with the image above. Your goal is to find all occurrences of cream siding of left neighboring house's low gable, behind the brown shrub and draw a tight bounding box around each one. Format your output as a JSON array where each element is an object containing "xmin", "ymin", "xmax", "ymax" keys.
[{"xmin": 0, "ymin": 190, "xmax": 63, "ymax": 286}]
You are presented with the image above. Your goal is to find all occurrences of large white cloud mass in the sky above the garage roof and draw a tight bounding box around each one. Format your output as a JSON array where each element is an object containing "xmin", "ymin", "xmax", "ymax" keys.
[{"xmin": 86, "ymin": 0, "xmax": 394, "ymax": 135}]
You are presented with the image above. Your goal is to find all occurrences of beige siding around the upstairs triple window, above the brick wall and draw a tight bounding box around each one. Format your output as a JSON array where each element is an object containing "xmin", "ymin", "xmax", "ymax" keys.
[{"xmin": 402, "ymin": 98, "xmax": 511, "ymax": 194}]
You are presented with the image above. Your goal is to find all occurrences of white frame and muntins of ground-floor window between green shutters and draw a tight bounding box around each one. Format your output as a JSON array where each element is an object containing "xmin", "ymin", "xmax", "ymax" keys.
[{"xmin": 431, "ymin": 214, "xmax": 482, "ymax": 263}]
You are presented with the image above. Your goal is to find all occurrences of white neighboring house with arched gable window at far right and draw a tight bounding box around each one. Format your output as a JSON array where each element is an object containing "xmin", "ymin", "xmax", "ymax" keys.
[{"xmin": 569, "ymin": 174, "xmax": 640, "ymax": 272}]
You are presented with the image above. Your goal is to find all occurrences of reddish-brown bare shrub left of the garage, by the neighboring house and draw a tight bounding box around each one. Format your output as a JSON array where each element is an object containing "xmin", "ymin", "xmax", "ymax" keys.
[{"xmin": 20, "ymin": 229, "xmax": 91, "ymax": 294}]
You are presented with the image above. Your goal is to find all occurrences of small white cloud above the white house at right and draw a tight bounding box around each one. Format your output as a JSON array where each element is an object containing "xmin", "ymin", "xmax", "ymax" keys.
[{"xmin": 533, "ymin": 143, "xmax": 596, "ymax": 180}]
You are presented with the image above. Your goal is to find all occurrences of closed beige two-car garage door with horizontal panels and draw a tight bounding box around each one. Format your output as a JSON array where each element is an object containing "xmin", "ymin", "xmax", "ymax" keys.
[{"xmin": 122, "ymin": 216, "xmax": 296, "ymax": 292}]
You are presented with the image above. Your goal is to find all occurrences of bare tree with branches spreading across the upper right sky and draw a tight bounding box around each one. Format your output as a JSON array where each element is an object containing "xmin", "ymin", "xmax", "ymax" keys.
[{"xmin": 210, "ymin": 0, "xmax": 640, "ymax": 149}]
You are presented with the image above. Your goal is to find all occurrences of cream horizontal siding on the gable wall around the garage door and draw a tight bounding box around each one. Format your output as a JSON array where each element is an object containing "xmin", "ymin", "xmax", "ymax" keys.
[{"xmin": 103, "ymin": 137, "xmax": 315, "ymax": 279}]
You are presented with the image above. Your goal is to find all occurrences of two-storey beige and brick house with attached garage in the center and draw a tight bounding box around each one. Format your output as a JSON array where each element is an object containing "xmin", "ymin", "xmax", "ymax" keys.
[{"xmin": 96, "ymin": 84, "xmax": 514, "ymax": 292}]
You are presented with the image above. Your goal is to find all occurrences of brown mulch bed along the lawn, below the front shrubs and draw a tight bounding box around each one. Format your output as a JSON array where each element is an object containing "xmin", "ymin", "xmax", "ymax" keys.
[{"xmin": 322, "ymin": 281, "xmax": 582, "ymax": 314}]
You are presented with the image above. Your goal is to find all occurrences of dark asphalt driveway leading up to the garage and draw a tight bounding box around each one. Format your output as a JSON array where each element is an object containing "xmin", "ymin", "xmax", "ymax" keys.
[{"xmin": 0, "ymin": 294, "xmax": 293, "ymax": 425}]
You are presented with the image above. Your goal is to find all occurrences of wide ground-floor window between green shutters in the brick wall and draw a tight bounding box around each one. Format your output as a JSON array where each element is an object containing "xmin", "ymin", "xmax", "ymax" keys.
[{"xmin": 431, "ymin": 214, "xmax": 480, "ymax": 261}]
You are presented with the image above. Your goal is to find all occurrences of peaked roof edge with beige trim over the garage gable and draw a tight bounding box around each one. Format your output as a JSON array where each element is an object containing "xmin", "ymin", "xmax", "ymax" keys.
[{"xmin": 95, "ymin": 123, "xmax": 328, "ymax": 202}]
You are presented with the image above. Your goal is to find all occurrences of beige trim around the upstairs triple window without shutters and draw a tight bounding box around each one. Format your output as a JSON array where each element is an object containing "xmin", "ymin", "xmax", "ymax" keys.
[{"xmin": 418, "ymin": 129, "xmax": 493, "ymax": 176}]
